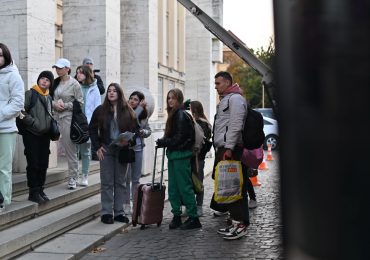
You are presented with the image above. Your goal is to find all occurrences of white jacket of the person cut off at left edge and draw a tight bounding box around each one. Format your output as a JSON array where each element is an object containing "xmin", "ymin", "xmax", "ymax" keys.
[{"xmin": 0, "ymin": 64, "xmax": 25, "ymax": 133}]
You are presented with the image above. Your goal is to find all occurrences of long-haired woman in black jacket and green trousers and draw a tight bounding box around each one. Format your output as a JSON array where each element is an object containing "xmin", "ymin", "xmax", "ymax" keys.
[{"xmin": 157, "ymin": 88, "xmax": 202, "ymax": 229}]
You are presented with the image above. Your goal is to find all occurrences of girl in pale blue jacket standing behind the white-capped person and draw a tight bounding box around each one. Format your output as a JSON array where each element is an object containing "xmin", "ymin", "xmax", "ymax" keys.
[{"xmin": 76, "ymin": 65, "xmax": 101, "ymax": 186}]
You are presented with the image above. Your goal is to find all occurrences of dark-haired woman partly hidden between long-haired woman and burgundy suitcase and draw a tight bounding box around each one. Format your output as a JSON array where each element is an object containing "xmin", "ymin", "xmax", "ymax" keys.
[{"xmin": 124, "ymin": 91, "xmax": 152, "ymax": 213}]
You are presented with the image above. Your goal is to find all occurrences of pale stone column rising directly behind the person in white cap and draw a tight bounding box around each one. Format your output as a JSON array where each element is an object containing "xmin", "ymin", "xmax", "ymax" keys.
[{"xmin": 63, "ymin": 0, "xmax": 120, "ymax": 87}]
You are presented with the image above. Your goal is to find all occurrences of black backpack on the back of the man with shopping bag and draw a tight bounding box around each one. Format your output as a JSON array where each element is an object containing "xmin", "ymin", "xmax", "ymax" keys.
[{"xmin": 243, "ymin": 105, "xmax": 265, "ymax": 150}]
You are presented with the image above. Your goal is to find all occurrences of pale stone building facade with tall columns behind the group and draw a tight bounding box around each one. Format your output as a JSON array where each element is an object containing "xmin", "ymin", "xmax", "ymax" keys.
[{"xmin": 0, "ymin": 0, "xmax": 223, "ymax": 175}]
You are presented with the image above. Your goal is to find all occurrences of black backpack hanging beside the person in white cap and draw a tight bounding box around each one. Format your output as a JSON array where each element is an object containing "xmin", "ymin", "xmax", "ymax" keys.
[{"xmin": 70, "ymin": 100, "xmax": 90, "ymax": 144}]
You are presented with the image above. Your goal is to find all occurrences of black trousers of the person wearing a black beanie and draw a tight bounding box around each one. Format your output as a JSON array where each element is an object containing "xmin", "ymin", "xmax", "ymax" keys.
[{"xmin": 23, "ymin": 132, "xmax": 50, "ymax": 190}]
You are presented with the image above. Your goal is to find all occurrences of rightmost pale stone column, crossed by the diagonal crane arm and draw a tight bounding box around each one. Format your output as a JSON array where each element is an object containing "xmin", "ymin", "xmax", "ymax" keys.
[{"xmin": 185, "ymin": 0, "xmax": 223, "ymax": 122}]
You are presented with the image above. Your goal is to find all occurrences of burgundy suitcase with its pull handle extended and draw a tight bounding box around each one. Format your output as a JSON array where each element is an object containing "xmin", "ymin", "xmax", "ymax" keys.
[{"xmin": 132, "ymin": 147, "xmax": 166, "ymax": 229}]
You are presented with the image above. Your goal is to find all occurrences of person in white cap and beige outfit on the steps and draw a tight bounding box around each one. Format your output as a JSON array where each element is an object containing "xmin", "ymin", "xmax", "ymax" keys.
[{"xmin": 51, "ymin": 58, "xmax": 84, "ymax": 189}]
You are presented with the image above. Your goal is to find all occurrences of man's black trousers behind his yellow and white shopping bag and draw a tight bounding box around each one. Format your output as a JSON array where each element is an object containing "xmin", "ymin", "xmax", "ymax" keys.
[{"xmin": 211, "ymin": 147, "xmax": 249, "ymax": 226}]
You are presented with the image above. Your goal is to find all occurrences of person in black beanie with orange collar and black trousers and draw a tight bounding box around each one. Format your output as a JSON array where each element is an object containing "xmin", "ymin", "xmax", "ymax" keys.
[{"xmin": 22, "ymin": 70, "xmax": 54, "ymax": 204}]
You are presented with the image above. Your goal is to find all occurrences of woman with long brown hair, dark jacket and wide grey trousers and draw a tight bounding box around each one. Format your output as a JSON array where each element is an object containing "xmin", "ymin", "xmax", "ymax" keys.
[{"xmin": 90, "ymin": 83, "xmax": 137, "ymax": 224}]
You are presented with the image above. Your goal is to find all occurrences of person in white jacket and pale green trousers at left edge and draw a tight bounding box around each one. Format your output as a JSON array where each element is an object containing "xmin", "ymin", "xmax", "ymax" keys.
[{"xmin": 0, "ymin": 43, "xmax": 24, "ymax": 211}]
